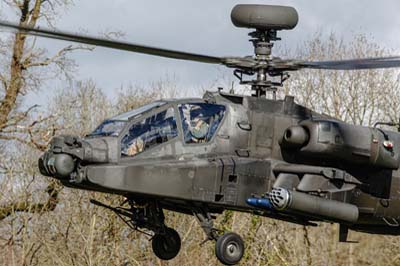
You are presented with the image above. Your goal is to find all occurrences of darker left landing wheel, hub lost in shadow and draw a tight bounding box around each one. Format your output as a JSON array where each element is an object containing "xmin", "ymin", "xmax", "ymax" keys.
[{"xmin": 151, "ymin": 227, "xmax": 181, "ymax": 260}]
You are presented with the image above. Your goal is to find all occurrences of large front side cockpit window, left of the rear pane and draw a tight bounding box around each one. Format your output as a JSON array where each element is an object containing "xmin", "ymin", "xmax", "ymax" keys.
[{"xmin": 121, "ymin": 107, "xmax": 178, "ymax": 156}]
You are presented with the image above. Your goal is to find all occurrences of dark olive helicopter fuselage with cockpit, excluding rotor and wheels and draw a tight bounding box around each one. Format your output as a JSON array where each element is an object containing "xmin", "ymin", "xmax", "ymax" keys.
[{"xmin": 41, "ymin": 93, "xmax": 400, "ymax": 234}]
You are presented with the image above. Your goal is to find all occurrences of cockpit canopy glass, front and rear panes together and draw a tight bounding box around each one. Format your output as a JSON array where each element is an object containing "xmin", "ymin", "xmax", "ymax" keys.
[{"xmin": 88, "ymin": 101, "xmax": 226, "ymax": 157}]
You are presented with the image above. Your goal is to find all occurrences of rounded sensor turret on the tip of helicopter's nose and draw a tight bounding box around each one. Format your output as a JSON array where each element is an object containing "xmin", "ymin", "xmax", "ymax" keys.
[{"xmin": 38, "ymin": 152, "xmax": 76, "ymax": 179}]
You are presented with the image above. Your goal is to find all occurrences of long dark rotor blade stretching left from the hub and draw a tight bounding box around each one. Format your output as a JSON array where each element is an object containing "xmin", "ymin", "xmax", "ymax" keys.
[{"xmin": 0, "ymin": 20, "xmax": 223, "ymax": 64}]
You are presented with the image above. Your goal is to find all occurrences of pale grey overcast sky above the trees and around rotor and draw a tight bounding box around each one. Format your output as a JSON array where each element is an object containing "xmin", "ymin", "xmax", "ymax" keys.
[{"xmin": 0, "ymin": 0, "xmax": 400, "ymax": 101}]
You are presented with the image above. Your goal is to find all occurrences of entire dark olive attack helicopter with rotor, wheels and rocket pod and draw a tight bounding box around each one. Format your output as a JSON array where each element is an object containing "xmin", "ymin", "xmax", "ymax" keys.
[{"xmin": 0, "ymin": 5, "xmax": 400, "ymax": 265}]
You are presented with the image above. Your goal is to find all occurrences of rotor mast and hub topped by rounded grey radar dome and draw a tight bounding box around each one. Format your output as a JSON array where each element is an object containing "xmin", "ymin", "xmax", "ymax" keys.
[{"xmin": 231, "ymin": 5, "xmax": 298, "ymax": 99}]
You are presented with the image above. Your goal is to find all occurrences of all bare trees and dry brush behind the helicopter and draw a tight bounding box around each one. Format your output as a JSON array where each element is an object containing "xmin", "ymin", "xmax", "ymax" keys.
[{"xmin": 0, "ymin": 0, "xmax": 400, "ymax": 265}]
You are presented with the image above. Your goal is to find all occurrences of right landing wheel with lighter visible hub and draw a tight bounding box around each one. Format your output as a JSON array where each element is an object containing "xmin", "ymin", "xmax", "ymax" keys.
[{"xmin": 215, "ymin": 233, "xmax": 244, "ymax": 265}]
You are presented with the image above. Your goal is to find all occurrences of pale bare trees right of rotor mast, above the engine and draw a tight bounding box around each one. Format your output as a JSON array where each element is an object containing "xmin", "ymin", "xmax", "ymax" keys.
[{"xmin": 284, "ymin": 33, "xmax": 400, "ymax": 125}]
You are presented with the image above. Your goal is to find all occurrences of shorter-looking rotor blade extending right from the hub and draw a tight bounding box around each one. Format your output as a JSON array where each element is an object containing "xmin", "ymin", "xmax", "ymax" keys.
[{"xmin": 297, "ymin": 56, "xmax": 400, "ymax": 70}]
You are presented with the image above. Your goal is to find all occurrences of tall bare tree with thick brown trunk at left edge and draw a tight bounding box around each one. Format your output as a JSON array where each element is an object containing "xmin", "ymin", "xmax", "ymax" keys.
[{"xmin": 0, "ymin": 0, "xmax": 85, "ymax": 234}]
